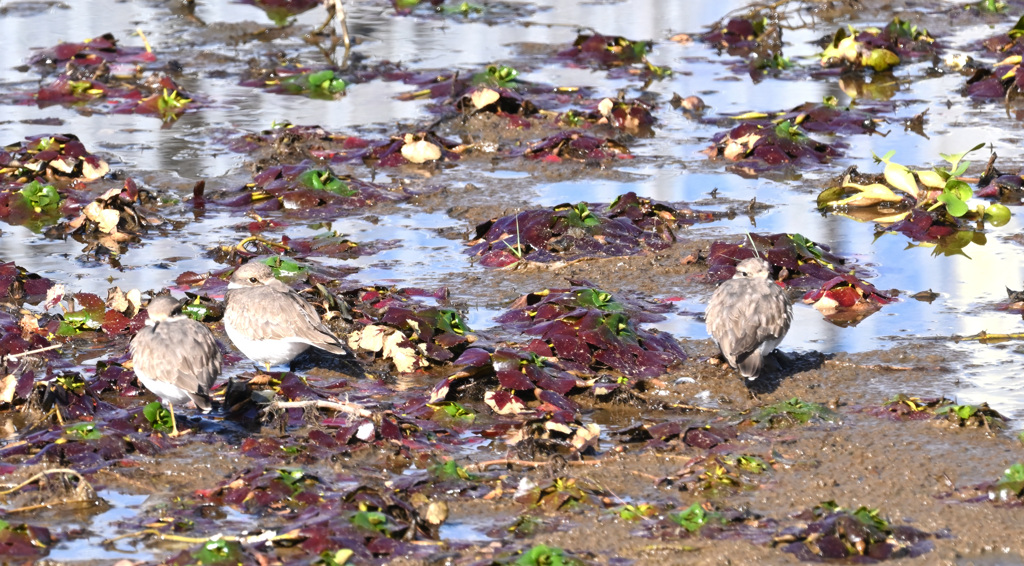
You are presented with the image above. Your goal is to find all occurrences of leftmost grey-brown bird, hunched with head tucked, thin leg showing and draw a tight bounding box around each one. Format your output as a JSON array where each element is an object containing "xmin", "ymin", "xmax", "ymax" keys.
[{"xmin": 129, "ymin": 295, "xmax": 222, "ymax": 437}]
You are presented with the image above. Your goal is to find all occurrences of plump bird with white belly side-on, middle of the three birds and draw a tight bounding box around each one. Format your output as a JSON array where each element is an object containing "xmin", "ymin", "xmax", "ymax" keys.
[{"xmin": 224, "ymin": 262, "xmax": 352, "ymax": 371}]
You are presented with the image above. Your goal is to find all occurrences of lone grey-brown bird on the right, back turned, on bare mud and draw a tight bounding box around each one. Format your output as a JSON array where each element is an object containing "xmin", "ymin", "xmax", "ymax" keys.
[{"xmin": 705, "ymin": 257, "xmax": 793, "ymax": 381}]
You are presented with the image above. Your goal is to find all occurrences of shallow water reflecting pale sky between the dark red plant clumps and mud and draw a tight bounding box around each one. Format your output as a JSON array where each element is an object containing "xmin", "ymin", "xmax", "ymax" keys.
[{"xmin": 0, "ymin": 0, "xmax": 1024, "ymax": 560}]
